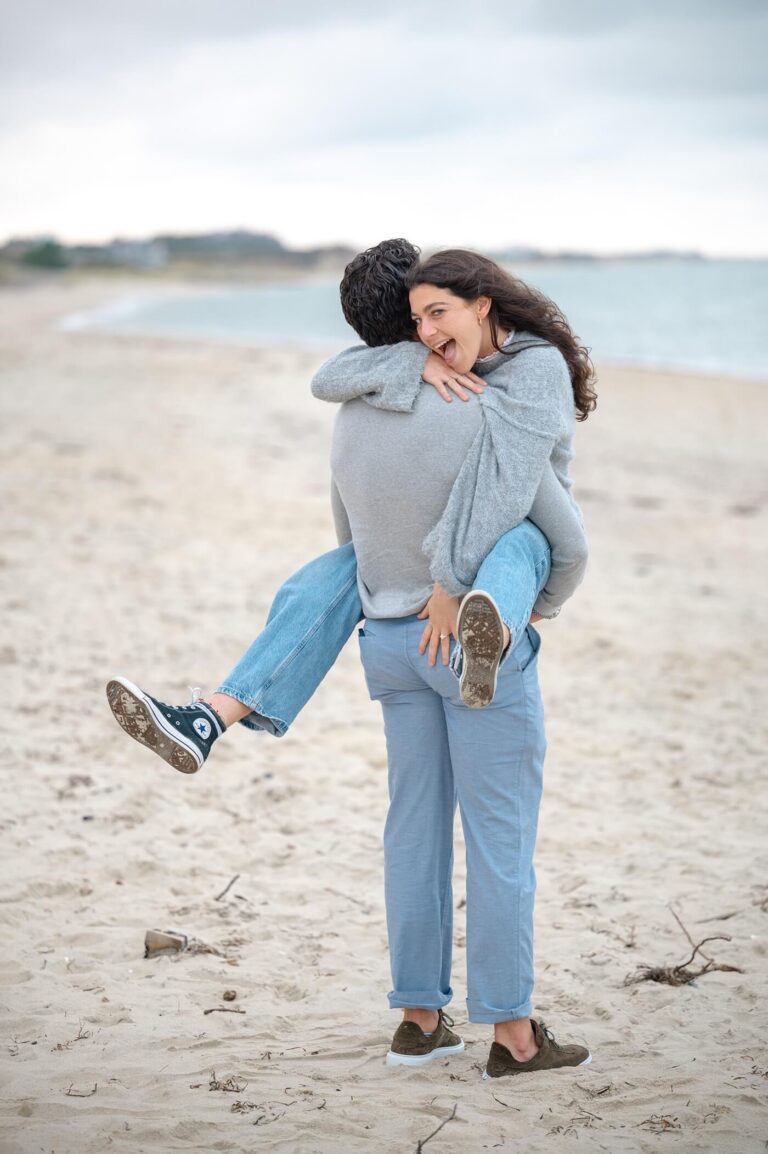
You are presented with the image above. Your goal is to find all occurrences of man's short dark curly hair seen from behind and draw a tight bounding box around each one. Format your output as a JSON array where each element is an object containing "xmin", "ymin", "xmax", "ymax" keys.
[{"xmin": 340, "ymin": 238, "xmax": 419, "ymax": 346}]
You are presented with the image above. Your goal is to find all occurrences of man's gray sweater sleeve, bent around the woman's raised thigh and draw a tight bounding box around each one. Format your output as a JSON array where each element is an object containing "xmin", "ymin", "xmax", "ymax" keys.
[{"xmin": 528, "ymin": 465, "xmax": 588, "ymax": 617}]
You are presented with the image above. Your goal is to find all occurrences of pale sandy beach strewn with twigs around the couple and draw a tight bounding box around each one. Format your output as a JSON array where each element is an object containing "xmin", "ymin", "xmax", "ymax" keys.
[{"xmin": 0, "ymin": 280, "xmax": 768, "ymax": 1154}]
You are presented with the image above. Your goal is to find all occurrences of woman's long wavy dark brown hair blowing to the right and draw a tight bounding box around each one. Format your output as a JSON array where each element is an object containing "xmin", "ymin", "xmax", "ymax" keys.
[{"xmin": 407, "ymin": 248, "xmax": 597, "ymax": 421}]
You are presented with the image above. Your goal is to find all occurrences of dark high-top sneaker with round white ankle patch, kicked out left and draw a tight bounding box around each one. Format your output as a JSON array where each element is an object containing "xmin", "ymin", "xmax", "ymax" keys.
[{"xmin": 107, "ymin": 677, "xmax": 226, "ymax": 773}]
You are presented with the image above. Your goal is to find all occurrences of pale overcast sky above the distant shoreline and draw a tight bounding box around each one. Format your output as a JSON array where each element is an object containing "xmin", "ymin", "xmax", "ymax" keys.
[{"xmin": 0, "ymin": 0, "xmax": 768, "ymax": 256}]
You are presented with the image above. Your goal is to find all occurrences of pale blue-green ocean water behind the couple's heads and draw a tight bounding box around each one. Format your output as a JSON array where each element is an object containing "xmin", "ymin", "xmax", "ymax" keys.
[{"xmin": 63, "ymin": 260, "xmax": 768, "ymax": 379}]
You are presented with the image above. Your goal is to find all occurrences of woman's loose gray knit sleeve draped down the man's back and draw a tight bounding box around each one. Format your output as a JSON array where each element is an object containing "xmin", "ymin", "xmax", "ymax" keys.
[{"xmin": 423, "ymin": 345, "xmax": 573, "ymax": 595}]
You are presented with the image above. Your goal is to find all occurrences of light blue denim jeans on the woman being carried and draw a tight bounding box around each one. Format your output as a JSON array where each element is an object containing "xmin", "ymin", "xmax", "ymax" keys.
[{"xmin": 217, "ymin": 520, "xmax": 550, "ymax": 737}]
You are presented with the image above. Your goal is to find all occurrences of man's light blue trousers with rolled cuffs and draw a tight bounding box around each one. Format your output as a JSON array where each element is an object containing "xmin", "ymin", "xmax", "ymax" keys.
[{"xmin": 360, "ymin": 616, "xmax": 545, "ymax": 1022}]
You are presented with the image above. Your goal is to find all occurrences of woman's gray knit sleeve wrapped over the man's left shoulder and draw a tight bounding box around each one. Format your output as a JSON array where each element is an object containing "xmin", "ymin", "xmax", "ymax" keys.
[{"xmin": 311, "ymin": 340, "xmax": 429, "ymax": 413}]
